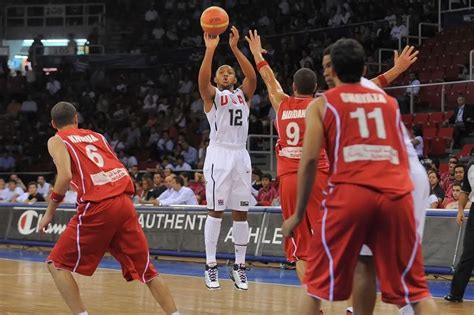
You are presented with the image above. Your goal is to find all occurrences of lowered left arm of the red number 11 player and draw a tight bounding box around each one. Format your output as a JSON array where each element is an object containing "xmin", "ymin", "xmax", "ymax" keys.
[{"xmin": 282, "ymin": 97, "xmax": 324, "ymax": 237}]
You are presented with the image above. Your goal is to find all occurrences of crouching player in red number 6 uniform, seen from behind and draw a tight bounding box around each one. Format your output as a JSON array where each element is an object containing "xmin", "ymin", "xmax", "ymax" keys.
[{"xmin": 39, "ymin": 102, "xmax": 179, "ymax": 315}]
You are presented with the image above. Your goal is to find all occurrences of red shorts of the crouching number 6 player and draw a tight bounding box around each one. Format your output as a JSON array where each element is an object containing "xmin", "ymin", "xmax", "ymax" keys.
[{"xmin": 48, "ymin": 195, "xmax": 158, "ymax": 282}]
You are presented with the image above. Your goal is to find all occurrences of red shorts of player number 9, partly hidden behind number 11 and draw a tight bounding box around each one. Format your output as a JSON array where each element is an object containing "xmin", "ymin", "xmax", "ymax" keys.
[{"xmin": 279, "ymin": 170, "xmax": 328, "ymax": 262}]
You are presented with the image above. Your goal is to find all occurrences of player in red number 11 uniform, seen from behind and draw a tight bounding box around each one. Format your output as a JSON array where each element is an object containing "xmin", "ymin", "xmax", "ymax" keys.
[{"xmin": 282, "ymin": 39, "xmax": 438, "ymax": 314}]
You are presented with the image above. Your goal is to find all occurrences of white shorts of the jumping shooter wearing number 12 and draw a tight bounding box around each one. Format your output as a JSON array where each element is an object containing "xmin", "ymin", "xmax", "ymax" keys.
[{"xmin": 204, "ymin": 145, "xmax": 252, "ymax": 211}]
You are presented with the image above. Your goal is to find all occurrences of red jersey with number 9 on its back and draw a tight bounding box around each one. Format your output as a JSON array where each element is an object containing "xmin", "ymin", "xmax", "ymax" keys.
[{"xmin": 276, "ymin": 96, "xmax": 329, "ymax": 176}]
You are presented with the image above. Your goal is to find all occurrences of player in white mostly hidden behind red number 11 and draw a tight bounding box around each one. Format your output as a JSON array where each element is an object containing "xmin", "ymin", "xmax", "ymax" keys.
[{"xmin": 323, "ymin": 46, "xmax": 430, "ymax": 315}]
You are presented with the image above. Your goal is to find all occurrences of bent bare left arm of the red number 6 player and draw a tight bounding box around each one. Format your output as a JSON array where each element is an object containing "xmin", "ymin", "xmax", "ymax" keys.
[{"xmin": 39, "ymin": 136, "xmax": 72, "ymax": 231}]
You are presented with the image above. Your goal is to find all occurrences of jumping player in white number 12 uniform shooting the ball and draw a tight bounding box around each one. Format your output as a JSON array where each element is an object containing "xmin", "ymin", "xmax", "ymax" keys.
[{"xmin": 198, "ymin": 26, "xmax": 257, "ymax": 290}]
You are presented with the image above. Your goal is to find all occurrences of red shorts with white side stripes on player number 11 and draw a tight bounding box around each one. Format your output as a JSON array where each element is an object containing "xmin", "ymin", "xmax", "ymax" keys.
[{"xmin": 304, "ymin": 184, "xmax": 431, "ymax": 305}]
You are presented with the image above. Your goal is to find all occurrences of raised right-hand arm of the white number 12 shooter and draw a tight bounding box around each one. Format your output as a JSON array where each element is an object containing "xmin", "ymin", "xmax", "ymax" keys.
[{"xmin": 229, "ymin": 26, "xmax": 257, "ymax": 100}]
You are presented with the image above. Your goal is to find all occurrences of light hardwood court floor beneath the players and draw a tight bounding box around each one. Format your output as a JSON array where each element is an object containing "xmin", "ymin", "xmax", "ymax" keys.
[{"xmin": 0, "ymin": 257, "xmax": 474, "ymax": 315}]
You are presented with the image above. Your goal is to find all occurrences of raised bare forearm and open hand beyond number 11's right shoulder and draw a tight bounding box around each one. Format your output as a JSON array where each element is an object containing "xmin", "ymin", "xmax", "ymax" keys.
[{"xmin": 371, "ymin": 46, "xmax": 419, "ymax": 88}]
